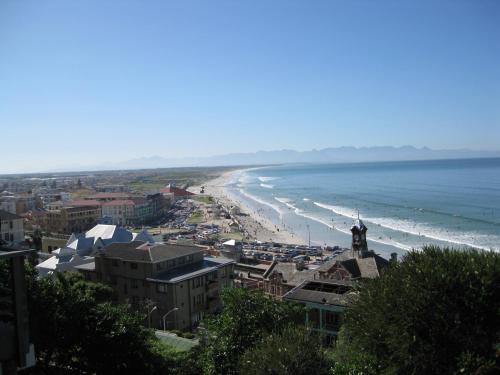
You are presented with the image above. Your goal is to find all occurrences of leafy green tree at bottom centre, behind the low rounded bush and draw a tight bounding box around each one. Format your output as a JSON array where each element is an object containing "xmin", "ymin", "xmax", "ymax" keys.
[{"xmin": 201, "ymin": 288, "xmax": 304, "ymax": 375}]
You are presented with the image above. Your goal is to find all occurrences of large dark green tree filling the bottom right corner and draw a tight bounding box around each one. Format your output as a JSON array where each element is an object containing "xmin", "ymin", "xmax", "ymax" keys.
[{"xmin": 338, "ymin": 246, "xmax": 500, "ymax": 374}]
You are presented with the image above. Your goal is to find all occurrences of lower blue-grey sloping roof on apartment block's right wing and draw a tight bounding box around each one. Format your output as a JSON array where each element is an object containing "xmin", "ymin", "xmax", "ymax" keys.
[{"xmin": 148, "ymin": 257, "xmax": 235, "ymax": 283}]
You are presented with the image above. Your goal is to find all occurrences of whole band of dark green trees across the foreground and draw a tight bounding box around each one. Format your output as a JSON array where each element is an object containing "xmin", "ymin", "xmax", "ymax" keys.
[{"xmin": 4, "ymin": 247, "xmax": 500, "ymax": 375}]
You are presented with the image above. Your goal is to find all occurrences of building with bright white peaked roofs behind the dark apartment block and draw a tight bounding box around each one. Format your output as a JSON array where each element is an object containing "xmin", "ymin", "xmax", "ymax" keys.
[{"xmin": 36, "ymin": 224, "xmax": 154, "ymax": 277}]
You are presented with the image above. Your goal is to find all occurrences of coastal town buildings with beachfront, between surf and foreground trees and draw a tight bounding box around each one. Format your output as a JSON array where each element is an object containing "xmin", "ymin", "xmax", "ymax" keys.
[{"xmin": 0, "ymin": 172, "xmax": 389, "ymax": 343}]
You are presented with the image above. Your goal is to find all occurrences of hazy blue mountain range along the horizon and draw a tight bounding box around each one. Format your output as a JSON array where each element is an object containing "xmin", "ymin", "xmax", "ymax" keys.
[{"xmin": 105, "ymin": 146, "xmax": 500, "ymax": 169}]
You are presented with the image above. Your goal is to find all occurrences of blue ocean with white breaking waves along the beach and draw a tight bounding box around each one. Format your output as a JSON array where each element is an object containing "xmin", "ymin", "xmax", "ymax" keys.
[{"xmin": 226, "ymin": 158, "xmax": 500, "ymax": 254}]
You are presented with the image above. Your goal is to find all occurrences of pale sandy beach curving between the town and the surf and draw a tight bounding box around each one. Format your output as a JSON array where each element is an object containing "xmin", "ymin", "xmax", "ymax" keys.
[{"xmin": 188, "ymin": 171, "xmax": 306, "ymax": 245}]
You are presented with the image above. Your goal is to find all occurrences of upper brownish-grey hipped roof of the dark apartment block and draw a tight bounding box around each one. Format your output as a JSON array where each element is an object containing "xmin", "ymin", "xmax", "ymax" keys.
[{"xmin": 93, "ymin": 241, "xmax": 201, "ymax": 262}]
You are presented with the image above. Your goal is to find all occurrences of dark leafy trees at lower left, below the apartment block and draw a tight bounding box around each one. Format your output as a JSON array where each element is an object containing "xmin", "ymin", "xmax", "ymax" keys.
[{"xmin": 23, "ymin": 272, "xmax": 180, "ymax": 374}]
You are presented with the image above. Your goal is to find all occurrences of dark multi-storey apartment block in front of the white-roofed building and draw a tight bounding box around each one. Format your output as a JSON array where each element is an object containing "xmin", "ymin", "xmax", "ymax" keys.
[{"xmin": 75, "ymin": 241, "xmax": 235, "ymax": 330}]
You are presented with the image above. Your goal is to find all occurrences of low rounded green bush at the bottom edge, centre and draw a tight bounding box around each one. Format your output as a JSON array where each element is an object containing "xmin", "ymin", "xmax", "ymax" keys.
[{"xmin": 240, "ymin": 326, "xmax": 330, "ymax": 375}]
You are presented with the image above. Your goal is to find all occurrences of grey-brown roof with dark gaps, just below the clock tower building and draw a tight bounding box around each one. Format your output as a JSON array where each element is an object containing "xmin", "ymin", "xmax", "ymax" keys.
[{"xmin": 283, "ymin": 280, "xmax": 355, "ymax": 306}]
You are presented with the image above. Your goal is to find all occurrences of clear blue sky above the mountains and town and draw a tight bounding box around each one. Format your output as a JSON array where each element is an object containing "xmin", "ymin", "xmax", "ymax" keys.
[{"xmin": 0, "ymin": 0, "xmax": 500, "ymax": 172}]
